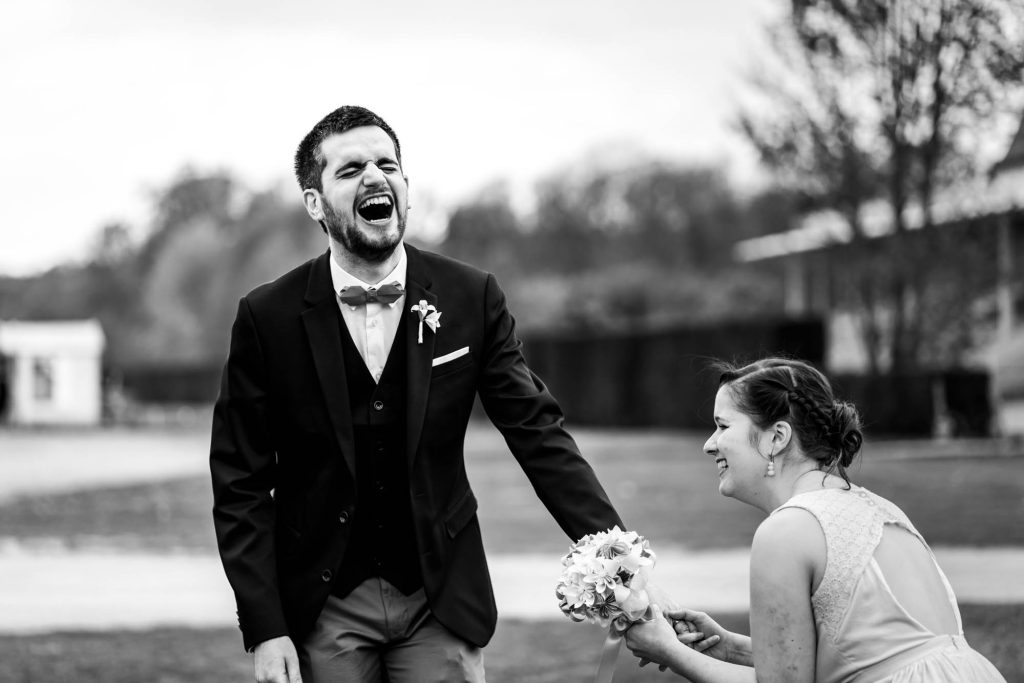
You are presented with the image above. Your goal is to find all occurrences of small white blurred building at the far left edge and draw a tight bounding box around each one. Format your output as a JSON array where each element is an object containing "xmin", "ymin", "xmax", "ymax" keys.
[{"xmin": 0, "ymin": 319, "xmax": 104, "ymax": 425}]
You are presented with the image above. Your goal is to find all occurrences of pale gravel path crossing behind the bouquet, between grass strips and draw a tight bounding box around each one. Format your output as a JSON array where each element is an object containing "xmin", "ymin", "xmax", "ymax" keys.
[{"xmin": 0, "ymin": 544, "xmax": 1024, "ymax": 633}]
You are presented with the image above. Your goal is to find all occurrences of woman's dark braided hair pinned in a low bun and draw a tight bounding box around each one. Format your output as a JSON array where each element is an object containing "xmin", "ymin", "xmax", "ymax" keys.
[{"xmin": 713, "ymin": 358, "xmax": 864, "ymax": 484}]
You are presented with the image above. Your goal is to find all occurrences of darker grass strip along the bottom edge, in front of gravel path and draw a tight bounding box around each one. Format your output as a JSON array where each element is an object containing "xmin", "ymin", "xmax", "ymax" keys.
[{"xmin": 0, "ymin": 605, "xmax": 1024, "ymax": 683}]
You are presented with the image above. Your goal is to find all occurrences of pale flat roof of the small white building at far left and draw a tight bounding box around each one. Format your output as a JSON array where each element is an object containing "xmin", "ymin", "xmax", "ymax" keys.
[{"xmin": 0, "ymin": 319, "xmax": 105, "ymax": 355}]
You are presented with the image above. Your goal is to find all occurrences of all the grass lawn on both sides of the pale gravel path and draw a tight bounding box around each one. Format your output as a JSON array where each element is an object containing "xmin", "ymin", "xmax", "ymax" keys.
[{"xmin": 0, "ymin": 430, "xmax": 1024, "ymax": 683}]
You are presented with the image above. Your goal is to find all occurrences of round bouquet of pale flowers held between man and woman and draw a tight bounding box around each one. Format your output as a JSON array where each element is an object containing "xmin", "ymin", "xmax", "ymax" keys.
[{"xmin": 555, "ymin": 526, "xmax": 655, "ymax": 633}]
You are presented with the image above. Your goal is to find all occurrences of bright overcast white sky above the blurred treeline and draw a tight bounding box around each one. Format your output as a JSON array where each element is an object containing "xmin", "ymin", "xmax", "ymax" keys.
[{"xmin": 0, "ymin": 0, "xmax": 785, "ymax": 274}]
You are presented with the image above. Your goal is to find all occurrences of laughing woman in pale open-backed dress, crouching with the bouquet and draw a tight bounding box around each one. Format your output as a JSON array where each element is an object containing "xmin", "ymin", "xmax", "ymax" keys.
[{"xmin": 626, "ymin": 358, "xmax": 1004, "ymax": 683}]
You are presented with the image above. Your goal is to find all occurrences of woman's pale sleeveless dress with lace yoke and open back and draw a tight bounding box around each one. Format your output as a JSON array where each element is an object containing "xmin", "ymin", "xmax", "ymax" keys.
[{"xmin": 772, "ymin": 486, "xmax": 1006, "ymax": 683}]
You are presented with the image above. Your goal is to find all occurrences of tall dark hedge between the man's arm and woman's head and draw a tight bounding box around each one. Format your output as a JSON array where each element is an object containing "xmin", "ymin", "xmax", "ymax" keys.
[{"xmin": 524, "ymin": 319, "xmax": 825, "ymax": 429}]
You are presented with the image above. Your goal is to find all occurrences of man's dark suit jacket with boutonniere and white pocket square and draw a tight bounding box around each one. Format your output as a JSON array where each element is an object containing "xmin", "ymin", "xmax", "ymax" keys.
[{"xmin": 210, "ymin": 246, "xmax": 622, "ymax": 648}]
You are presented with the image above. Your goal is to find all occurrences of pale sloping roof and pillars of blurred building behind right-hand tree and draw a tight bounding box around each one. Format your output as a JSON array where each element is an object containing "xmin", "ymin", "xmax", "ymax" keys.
[{"xmin": 734, "ymin": 112, "xmax": 1024, "ymax": 434}]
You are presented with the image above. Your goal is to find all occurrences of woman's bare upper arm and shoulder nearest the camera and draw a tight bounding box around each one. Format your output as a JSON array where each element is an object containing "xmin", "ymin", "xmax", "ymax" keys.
[{"xmin": 751, "ymin": 509, "xmax": 825, "ymax": 683}]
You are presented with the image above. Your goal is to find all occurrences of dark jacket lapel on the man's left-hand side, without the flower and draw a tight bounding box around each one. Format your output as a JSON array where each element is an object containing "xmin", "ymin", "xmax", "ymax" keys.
[{"xmin": 302, "ymin": 252, "xmax": 355, "ymax": 476}]
